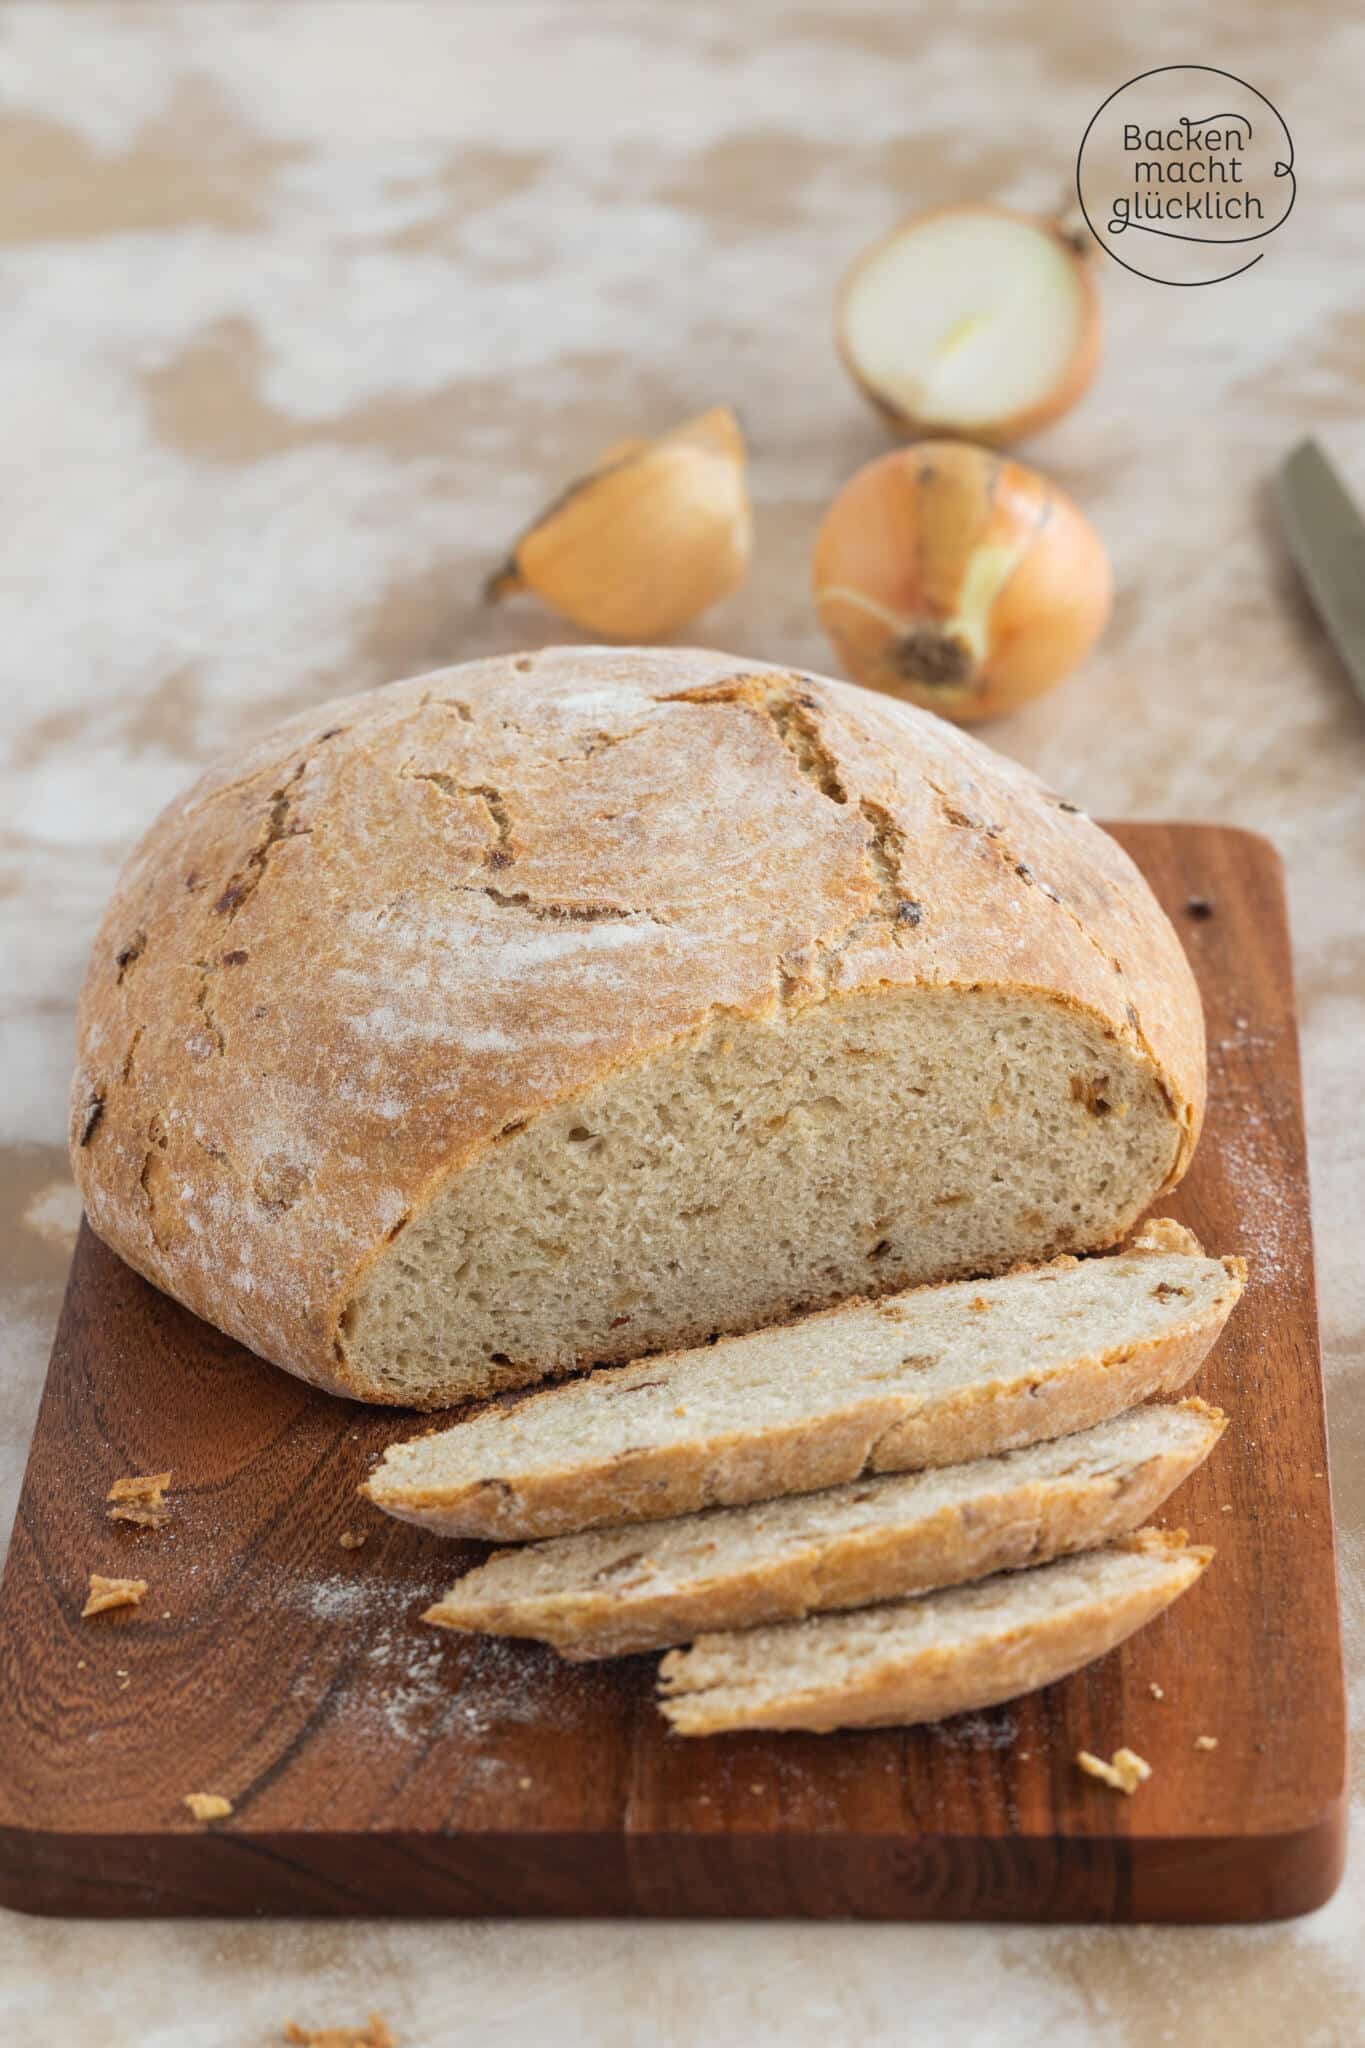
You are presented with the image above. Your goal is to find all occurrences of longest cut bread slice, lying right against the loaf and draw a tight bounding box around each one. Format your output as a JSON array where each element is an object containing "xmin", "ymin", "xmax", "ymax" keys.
[{"xmin": 364, "ymin": 1249, "xmax": 1244, "ymax": 1540}]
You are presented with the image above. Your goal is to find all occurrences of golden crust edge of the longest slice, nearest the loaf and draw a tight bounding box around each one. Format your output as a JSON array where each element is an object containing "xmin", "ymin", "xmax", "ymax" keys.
[{"xmin": 362, "ymin": 1253, "xmax": 1246, "ymax": 1542}]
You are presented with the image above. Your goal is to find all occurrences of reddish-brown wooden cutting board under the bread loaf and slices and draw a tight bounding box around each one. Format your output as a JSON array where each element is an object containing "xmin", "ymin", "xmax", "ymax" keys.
[{"xmin": 0, "ymin": 825, "xmax": 1345, "ymax": 1921}]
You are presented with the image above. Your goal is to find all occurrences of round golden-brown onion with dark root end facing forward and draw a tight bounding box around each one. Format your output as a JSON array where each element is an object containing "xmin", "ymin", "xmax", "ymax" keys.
[{"xmin": 812, "ymin": 440, "xmax": 1111, "ymax": 723}]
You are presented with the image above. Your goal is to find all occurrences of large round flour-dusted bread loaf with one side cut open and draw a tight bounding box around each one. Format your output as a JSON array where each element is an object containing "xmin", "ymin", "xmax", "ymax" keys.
[{"xmin": 72, "ymin": 647, "xmax": 1203, "ymax": 1407}]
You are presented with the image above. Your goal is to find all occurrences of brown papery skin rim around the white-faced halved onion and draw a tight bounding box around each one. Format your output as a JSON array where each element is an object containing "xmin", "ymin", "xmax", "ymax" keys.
[{"xmin": 835, "ymin": 205, "xmax": 1103, "ymax": 449}]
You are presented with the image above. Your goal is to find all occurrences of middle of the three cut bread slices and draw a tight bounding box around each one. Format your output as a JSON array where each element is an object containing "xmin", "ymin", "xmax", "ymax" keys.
[{"xmin": 424, "ymin": 1401, "xmax": 1226, "ymax": 1659}]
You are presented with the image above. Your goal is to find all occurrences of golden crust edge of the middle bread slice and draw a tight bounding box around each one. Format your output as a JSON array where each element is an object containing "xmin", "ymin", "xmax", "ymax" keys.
[{"xmin": 424, "ymin": 1399, "xmax": 1226, "ymax": 1661}]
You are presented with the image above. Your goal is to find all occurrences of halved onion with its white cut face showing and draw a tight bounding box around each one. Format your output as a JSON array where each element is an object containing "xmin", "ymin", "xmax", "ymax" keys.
[{"xmin": 837, "ymin": 207, "xmax": 1101, "ymax": 444}]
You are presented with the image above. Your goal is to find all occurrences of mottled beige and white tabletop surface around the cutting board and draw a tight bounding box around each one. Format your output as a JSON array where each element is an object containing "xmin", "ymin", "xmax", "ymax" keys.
[{"xmin": 0, "ymin": 0, "xmax": 1365, "ymax": 2048}]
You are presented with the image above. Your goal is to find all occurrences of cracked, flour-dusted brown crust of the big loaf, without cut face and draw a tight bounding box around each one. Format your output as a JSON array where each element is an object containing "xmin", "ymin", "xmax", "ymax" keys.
[{"xmin": 72, "ymin": 647, "xmax": 1203, "ymax": 1401}]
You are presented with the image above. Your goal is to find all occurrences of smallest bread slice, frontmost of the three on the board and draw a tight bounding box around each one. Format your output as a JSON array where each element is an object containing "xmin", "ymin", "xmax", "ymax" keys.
[{"xmin": 659, "ymin": 1530, "xmax": 1214, "ymax": 1735}]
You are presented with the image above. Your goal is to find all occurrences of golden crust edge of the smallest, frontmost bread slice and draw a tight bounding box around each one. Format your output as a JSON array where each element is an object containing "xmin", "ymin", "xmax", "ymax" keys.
[{"xmin": 659, "ymin": 1530, "xmax": 1214, "ymax": 1735}]
